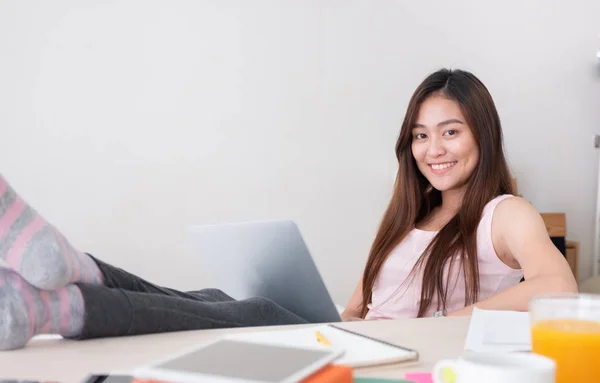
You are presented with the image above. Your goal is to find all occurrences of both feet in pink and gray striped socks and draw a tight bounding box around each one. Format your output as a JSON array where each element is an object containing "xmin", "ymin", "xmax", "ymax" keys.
[{"xmin": 0, "ymin": 175, "xmax": 102, "ymax": 350}]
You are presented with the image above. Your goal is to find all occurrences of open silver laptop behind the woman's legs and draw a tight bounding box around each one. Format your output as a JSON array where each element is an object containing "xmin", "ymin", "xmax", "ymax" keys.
[{"xmin": 189, "ymin": 220, "xmax": 341, "ymax": 323}]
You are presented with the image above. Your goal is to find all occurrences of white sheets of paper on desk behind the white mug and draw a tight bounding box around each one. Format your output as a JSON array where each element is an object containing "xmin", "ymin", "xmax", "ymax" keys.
[{"xmin": 465, "ymin": 308, "xmax": 531, "ymax": 352}]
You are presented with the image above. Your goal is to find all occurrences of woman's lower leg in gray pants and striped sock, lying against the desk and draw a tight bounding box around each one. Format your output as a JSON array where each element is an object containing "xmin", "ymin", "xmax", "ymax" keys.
[{"xmin": 0, "ymin": 269, "xmax": 307, "ymax": 350}]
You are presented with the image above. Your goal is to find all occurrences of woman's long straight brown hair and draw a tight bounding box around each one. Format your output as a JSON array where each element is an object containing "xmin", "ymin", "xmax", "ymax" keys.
[{"xmin": 361, "ymin": 69, "xmax": 513, "ymax": 317}]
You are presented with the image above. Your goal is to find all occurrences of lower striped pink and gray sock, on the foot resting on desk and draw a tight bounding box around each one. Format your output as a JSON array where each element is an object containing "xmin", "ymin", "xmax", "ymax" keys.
[{"xmin": 0, "ymin": 268, "xmax": 85, "ymax": 350}]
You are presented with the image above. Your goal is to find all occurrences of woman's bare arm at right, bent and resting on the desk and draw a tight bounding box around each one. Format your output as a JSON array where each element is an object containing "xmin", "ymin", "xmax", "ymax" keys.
[{"xmin": 448, "ymin": 197, "xmax": 577, "ymax": 316}]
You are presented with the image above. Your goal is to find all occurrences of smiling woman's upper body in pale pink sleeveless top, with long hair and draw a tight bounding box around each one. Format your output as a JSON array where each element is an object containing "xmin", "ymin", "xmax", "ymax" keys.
[{"xmin": 342, "ymin": 69, "xmax": 577, "ymax": 320}]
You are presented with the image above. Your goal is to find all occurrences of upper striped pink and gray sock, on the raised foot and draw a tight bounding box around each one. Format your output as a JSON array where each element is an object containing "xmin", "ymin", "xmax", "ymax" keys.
[{"xmin": 0, "ymin": 175, "xmax": 103, "ymax": 290}]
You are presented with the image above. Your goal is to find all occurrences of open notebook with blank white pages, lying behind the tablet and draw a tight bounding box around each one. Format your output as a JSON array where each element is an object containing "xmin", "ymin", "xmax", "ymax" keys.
[{"xmin": 226, "ymin": 325, "xmax": 419, "ymax": 368}]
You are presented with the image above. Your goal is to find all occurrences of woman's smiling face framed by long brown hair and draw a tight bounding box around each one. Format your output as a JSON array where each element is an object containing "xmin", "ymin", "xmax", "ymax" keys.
[{"xmin": 412, "ymin": 95, "xmax": 479, "ymax": 192}]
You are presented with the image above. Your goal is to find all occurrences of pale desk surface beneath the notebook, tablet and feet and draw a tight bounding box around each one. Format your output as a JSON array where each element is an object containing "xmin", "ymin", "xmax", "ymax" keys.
[{"xmin": 0, "ymin": 317, "xmax": 469, "ymax": 383}]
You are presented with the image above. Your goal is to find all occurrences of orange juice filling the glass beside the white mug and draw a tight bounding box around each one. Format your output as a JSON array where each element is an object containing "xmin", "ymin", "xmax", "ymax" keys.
[{"xmin": 531, "ymin": 319, "xmax": 600, "ymax": 383}]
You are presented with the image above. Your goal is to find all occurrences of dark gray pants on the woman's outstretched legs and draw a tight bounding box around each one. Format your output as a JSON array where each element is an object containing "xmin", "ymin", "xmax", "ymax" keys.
[{"xmin": 77, "ymin": 257, "xmax": 307, "ymax": 339}]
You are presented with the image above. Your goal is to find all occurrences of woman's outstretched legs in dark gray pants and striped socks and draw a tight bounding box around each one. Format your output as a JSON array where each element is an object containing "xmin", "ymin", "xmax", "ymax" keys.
[{"xmin": 0, "ymin": 175, "xmax": 307, "ymax": 350}]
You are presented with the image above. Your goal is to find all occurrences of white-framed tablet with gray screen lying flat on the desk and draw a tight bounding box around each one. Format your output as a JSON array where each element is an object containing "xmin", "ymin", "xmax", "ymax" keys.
[{"xmin": 134, "ymin": 339, "xmax": 343, "ymax": 383}]
